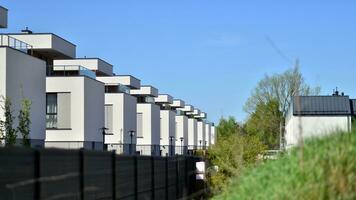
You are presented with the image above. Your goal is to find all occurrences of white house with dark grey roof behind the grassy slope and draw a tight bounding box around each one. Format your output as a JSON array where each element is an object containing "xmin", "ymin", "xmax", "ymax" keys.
[{"xmin": 285, "ymin": 92, "xmax": 354, "ymax": 148}]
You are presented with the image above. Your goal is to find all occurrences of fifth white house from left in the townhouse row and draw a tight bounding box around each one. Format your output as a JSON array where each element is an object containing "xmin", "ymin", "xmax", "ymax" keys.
[{"xmin": 155, "ymin": 94, "xmax": 176, "ymax": 155}]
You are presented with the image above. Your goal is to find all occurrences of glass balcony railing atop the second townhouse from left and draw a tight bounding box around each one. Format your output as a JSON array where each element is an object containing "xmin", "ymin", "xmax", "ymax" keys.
[{"xmin": 47, "ymin": 65, "xmax": 96, "ymax": 79}]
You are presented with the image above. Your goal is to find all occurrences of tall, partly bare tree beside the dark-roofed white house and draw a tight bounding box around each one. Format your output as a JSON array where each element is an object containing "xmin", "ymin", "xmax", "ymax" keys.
[{"xmin": 244, "ymin": 61, "xmax": 320, "ymax": 147}]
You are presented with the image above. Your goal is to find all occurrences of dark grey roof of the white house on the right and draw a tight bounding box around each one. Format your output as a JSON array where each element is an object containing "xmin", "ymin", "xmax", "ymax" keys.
[{"xmin": 293, "ymin": 96, "xmax": 356, "ymax": 115}]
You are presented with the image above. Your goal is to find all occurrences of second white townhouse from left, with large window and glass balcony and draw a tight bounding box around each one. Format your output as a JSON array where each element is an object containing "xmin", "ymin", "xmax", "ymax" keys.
[{"xmin": 46, "ymin": 58, "xmax": 112, "ymax": 149}]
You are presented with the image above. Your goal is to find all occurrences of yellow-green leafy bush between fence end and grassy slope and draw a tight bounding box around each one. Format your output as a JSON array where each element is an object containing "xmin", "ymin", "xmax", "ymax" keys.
[{"xmin": 207, "ymin": 117, "xmax": 265, "ymax": 193}]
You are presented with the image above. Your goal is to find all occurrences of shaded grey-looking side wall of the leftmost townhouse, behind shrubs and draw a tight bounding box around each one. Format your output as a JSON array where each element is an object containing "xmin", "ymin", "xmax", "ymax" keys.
[{"xmin": 0, "ymin": 47, "xmax": 46, "ymax": 146}]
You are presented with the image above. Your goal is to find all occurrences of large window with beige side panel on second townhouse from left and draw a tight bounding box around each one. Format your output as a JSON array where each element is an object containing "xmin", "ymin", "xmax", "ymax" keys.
[{"xmin": 46, "ymin": 93, "xmax": 71, "ymax": 129}]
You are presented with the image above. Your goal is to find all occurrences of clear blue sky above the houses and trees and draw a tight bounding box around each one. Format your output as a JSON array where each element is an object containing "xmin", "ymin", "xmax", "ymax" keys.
[{"xmin": 0, "ymin": 0, "xmax": 356, "ymax": 122}]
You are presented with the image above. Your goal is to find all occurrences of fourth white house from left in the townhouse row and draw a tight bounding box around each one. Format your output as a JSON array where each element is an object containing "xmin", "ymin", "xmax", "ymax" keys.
[{"xmin": 130, "ymin": 86, "xmax": 161, "ymax": 156}]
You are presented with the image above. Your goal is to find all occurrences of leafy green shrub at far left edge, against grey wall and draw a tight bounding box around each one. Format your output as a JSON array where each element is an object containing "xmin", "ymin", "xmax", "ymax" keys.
[{"xmin": 1, "ymin": 97, "xmax": 17, "ymax": 146}]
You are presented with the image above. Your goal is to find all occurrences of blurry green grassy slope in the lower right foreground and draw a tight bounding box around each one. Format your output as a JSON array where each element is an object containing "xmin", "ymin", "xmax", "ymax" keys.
[{"xmin": 214, "ymin": 131, "xmax": 356, "ymax": 200}]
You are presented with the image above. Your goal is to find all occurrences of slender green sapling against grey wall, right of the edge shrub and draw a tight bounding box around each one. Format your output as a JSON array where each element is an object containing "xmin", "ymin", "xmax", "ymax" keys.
[{"xmin": 17, "ymin": 98, "xmax": 32, "ymax": 147}]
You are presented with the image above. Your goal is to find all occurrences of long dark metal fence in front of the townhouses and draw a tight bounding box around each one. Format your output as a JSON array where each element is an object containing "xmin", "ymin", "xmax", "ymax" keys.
[{"xmin": 0, "ymin": 148, "xmax": 201, "ymax": 200}]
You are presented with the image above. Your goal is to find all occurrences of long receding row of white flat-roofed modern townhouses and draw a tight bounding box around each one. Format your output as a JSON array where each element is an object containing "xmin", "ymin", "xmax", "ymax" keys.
[{"xmin": 0, "ymin": 7, "xmax": 216, "ymax": 155}]
